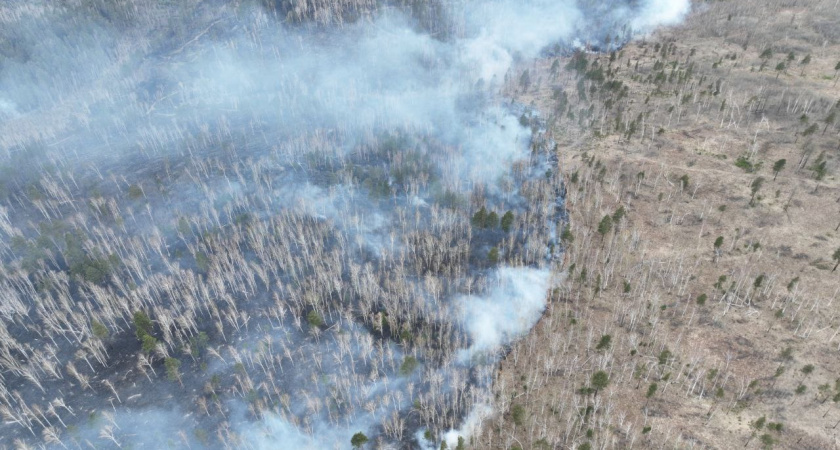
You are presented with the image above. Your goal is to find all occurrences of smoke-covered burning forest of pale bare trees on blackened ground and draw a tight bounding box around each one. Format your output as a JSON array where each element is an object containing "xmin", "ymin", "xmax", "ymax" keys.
[{"xmin": 0, "ymin": 0, "xmax": 688, "ymax": 448}]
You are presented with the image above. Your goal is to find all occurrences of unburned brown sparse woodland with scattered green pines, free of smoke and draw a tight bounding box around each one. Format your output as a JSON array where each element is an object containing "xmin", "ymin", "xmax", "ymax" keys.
[{"xmin": 474, "ymin": 1, "xmax": 840, "ymax": 449}]
